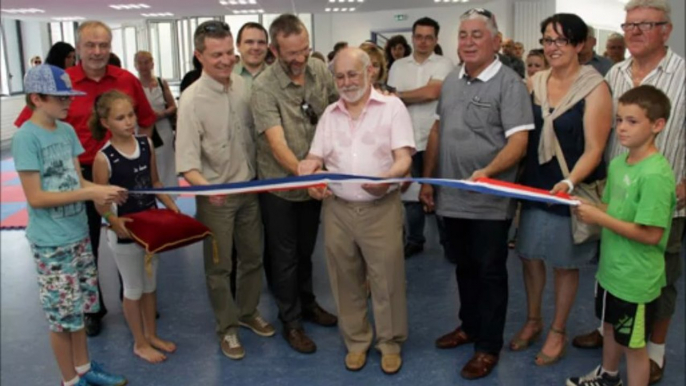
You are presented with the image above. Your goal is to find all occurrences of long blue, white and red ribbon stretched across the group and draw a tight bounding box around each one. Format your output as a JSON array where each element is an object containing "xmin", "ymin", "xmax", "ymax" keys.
[{"xmin": 131, "ymin": 173, "xmax": 579, "ymax": 206}]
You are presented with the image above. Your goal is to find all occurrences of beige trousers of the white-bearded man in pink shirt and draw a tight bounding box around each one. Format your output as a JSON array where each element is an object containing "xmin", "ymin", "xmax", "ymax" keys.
[{"xmin": 323, "ymin": 191, "xmax": 407, "ymax": 354}]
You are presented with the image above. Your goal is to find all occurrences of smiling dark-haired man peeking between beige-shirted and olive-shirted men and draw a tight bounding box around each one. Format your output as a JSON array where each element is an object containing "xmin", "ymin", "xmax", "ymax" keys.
[{"xmin": 233, "ymin": 22, "xmax": 269, "ymax": 92}]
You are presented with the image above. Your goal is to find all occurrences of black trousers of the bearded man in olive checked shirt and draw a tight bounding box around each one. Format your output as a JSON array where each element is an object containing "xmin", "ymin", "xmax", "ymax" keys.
[{"xmin": 260, "ymin": 193, "xmax": 321, "ymax": 328}]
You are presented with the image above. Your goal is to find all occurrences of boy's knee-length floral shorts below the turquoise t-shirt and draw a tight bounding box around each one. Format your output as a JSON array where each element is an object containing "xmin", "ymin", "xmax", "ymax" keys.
[{"xmin": 31, "ymin": 238, "xmax": 100, "ymax": 332}]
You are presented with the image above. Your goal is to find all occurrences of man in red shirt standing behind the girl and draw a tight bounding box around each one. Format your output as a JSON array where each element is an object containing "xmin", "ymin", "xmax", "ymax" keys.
[{"xmin": 14, "ymin": 21, "xmax": 157, "ymax": 336}]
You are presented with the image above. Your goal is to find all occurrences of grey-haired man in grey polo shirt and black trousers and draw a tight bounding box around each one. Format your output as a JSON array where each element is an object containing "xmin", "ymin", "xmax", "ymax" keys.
[{"xmin": 420, "ymin": 8, "xmax": 534, "ymax": 379}]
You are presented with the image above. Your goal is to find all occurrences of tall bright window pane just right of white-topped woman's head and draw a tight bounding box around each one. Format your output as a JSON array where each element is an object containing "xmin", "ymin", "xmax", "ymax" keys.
[{"xmin": 149, "ymin": 21, "xmax": 179, "ymax": 79}]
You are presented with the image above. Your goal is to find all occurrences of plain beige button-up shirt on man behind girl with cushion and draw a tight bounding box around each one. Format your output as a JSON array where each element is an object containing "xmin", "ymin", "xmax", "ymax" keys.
[{"xmin": 176, "ymin": 72, "xmax": 255, "ymax": 184}]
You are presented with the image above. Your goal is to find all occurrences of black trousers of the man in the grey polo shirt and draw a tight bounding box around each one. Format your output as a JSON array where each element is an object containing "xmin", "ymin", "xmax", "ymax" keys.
[{"xmin": 444, "ymin": 217, "xmax": 511, "ymax": 355}]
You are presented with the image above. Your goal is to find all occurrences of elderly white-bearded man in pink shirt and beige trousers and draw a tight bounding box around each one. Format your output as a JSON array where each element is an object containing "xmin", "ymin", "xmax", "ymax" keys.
[{"xmin": 298, "ymin": 48, "xmax": 415, "ymax": 374}]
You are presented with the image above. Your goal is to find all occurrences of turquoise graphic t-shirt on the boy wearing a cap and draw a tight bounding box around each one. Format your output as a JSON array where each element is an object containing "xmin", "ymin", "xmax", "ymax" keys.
[{"xmin": 12, "ymin": 121, "xmax": 88, "ymax": 246}]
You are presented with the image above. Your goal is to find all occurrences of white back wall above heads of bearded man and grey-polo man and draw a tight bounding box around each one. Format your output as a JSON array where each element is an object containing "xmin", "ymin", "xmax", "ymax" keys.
[{"xmin": 314, "ymin": 0, "xmax": 514, "ymax": 63}]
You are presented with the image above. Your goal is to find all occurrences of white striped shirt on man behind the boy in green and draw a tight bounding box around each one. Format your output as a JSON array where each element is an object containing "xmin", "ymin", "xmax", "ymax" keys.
[{"xmin": 605, "ymin": 49, "xmax": 686, "ymax": 217}]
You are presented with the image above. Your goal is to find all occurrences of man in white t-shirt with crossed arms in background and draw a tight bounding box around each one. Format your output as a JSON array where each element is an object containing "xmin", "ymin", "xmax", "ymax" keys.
[{"xmin": 388, "ymin": 17, "xmax": 454, "ymax": 257}]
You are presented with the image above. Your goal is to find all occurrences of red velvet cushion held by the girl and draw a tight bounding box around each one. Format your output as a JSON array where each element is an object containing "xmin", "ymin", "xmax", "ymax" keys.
[{"xmin": 122, "ymin": 209, "xmax": 212, "ymax": 255}]
